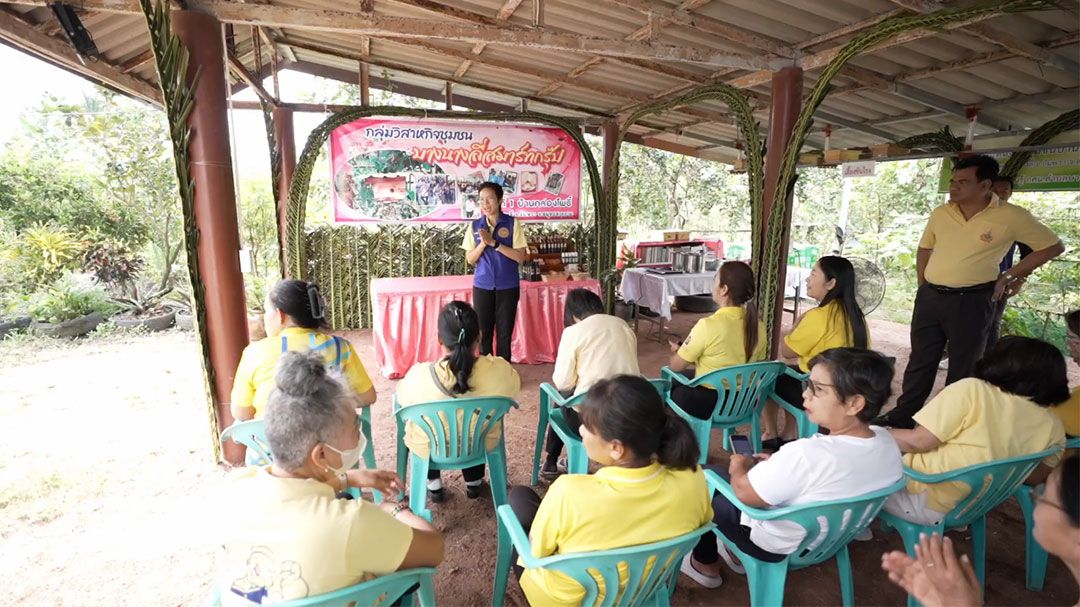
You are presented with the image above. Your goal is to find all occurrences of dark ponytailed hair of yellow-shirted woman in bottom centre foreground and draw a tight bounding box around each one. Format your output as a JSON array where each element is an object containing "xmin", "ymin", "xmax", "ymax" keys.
[{"xmin": 581, "ymin": 375, "xmax": 700, "ymax": 470}]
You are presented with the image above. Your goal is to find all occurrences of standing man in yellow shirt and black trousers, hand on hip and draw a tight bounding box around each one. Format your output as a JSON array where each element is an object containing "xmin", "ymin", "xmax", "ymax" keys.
[{"xmin": 875, "ymin": 156, "xmax": 1065, "ymax": 429}]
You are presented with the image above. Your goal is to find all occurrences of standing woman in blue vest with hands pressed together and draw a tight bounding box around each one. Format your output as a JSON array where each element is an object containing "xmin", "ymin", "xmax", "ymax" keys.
[{"xmin": 461, "ymin": 181, "xmax": 528, "ymax": 362}]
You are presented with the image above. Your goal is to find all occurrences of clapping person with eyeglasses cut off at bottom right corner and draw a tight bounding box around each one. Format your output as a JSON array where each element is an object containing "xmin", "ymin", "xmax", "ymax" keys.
[{"xmin": 881, "ymin": 455, "xmax": 1080, "ymax": 607}]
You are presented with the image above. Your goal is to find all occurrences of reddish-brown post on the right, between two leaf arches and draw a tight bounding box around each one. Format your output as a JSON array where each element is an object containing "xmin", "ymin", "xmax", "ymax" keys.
[{"xmin": 755, "ymin": 67, "xmax": 802, "ymax": 353}]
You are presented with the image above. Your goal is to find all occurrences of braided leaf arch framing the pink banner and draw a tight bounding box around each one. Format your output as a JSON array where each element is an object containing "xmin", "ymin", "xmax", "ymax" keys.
[{"xmin": 285, "ymin": 107, "xmax": 615, "ymax": 279}]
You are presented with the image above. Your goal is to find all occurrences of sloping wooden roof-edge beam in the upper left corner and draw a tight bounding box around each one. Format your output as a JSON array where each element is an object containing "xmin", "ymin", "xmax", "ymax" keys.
[{"xmin": 0, "ymin": 8, "xmax": 161, "ymax": 106}]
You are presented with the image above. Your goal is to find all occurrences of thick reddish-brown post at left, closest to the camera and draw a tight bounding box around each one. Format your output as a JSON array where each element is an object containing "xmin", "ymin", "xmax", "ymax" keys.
[{"xmin": 173, "ymin": 11, "xmax": 248, "ymax": 464}]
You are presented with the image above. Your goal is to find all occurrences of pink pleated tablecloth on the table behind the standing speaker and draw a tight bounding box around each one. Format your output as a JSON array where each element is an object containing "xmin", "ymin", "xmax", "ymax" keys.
[{"xmin": 372, "ymin": 276, "xmax": 600, "ymax": 379}]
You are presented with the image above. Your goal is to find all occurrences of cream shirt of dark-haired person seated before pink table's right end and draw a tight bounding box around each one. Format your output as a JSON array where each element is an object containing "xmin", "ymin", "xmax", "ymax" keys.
[{"xmin": 551, "ymin": 314, "xmax": 642, "ymax": 395}]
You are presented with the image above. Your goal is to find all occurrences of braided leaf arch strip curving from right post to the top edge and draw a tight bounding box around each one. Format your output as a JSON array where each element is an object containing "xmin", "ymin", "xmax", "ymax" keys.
[{"xmin": 758, "ymin": 0, "xmax": 1053, "ymax": 355}]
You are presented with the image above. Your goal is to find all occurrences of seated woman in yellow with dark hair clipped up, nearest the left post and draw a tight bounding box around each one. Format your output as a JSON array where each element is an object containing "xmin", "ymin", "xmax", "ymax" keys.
[{"xmin": 232, "ymin": 280, "xmax": 376, "ymax": 421}]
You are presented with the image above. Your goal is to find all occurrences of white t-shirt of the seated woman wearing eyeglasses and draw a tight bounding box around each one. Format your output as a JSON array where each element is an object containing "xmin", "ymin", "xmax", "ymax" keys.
[{"xmin": 740, "ymin": 426, "xmax": 904, "ymax": 554}]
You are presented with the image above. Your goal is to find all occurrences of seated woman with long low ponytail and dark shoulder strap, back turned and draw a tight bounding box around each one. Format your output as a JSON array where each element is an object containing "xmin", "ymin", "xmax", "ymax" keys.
[{"xmin": 394, "ymin": 301, "xmax": 522, "ymax": 503}]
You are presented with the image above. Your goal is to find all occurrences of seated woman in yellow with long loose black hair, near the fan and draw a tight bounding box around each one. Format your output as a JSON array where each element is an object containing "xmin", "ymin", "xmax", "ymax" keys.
[{"xmin": 761, "ymin": 255, "xmax": 870, "ymax": 450}]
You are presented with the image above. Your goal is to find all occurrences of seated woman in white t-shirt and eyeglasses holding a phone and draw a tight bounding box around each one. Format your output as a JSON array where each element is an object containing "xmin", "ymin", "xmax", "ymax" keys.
[{"xmin": 681, "ymin": 348, "xmax": 903, "ymax": 588}]
